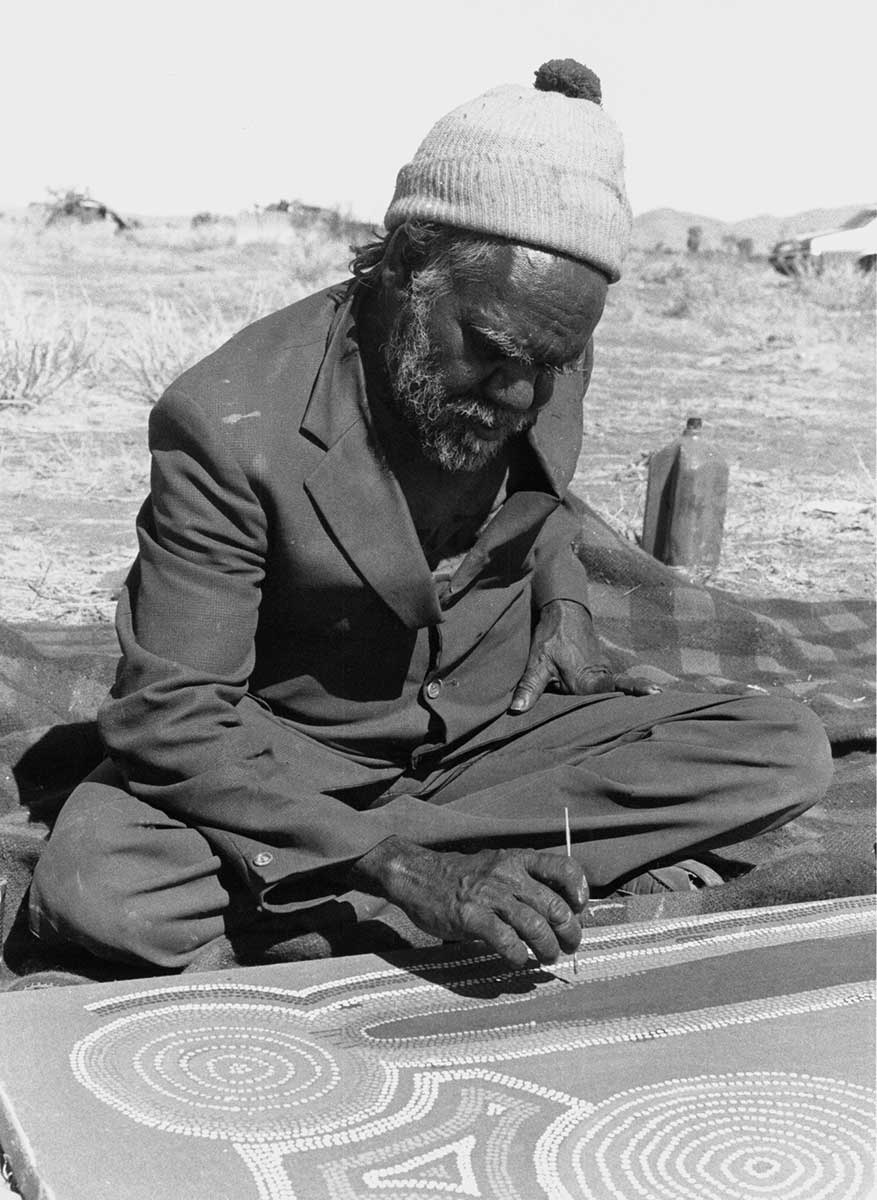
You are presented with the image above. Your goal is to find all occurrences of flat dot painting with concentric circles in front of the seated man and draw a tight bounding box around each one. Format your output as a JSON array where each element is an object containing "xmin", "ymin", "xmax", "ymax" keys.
[{"xmin": 0, "ymin": 898, "xmax": 875, "ymax": 1200}]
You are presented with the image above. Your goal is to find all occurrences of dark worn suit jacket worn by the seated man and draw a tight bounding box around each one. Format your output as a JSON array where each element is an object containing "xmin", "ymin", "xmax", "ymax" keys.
[{"xmin": 100, "ymin": 283, "xmax": 587, "ymax": 893}]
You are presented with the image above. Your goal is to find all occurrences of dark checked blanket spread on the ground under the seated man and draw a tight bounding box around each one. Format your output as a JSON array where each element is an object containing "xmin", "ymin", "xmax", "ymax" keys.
[{"xmin": 0, "ymin": 509, "xmax": 875, "ymax": 974}]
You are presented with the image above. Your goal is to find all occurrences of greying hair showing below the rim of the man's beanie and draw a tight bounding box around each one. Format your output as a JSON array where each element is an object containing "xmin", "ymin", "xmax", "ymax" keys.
[{"xmin": 350, "ymin": 221, "xmax": 511, "ymax": 295}]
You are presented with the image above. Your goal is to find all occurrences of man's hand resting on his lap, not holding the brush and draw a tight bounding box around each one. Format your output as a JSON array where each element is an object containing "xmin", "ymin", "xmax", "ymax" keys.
[{"xmin": 509, "ymin": 600, "xmax": 661, "ymax": 713}]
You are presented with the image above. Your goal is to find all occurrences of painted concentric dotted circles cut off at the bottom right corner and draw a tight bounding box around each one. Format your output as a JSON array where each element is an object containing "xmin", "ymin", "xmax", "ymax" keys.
[{"xmin": 559, "ymin": 1072, "xmax": 875, "ymax": 1200}]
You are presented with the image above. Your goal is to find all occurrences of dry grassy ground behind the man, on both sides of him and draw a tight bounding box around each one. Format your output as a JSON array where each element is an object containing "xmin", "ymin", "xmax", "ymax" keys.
[{"xmin": 0, "ymin": 217, "xmax": 875, "ymax": 620}]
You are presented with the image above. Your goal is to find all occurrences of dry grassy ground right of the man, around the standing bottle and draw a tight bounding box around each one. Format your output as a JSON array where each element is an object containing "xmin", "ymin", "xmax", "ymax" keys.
[{"xmin": 576, "ymin": 253, "xmax": 875, "ymax": 599}]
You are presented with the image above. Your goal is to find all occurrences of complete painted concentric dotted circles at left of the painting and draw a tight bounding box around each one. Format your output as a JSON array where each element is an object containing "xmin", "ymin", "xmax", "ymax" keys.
[{"xmin": 71, "ymin": 1001, "xmax": 360, "ymax": 1142}]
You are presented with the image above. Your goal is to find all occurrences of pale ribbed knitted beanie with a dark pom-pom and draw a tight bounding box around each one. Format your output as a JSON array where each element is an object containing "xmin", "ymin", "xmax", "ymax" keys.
[{"xmin": 384, "ymin": 59, "xmax": 631, "ymax": 282}]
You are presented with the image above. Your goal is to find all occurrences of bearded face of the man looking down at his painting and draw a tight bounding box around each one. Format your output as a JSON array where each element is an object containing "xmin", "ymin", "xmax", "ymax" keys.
[{"xmin": 386, "ymin": 246, "xmax": 607, "ymax": 472}]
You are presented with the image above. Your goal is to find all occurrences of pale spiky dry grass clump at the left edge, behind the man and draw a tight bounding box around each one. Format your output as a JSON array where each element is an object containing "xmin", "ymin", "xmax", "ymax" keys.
[{"xmin": 0, "ymin": 283, "xmax": 96, "ymax": 410}]
